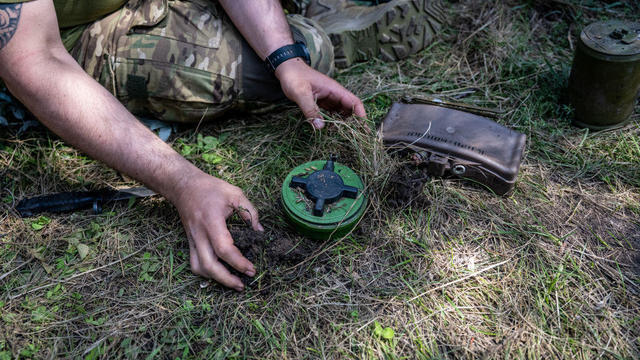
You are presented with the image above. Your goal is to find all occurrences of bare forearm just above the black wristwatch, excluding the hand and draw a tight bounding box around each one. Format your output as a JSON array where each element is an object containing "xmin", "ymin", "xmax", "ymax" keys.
[{"xmin": 220, "ymin": 0, "xmax": 293, "ymax": 59}]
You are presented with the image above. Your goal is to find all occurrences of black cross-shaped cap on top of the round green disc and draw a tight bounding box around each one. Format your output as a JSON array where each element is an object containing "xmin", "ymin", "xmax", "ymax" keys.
[{"xmin": 289, "ymin": 155, "xmax": 358, "ymax": 216}]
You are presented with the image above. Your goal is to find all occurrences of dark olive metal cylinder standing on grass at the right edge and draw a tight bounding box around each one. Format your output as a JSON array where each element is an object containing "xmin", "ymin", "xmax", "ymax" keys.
[{"xmin": 569, "ymin": 20, "xmax": 640, "ymax": 130}]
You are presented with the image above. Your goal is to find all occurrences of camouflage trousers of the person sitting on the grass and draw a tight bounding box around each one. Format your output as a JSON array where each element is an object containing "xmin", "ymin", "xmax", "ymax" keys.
[{"xmin": 71, "ymin": 0, "xmax": 334, "ymax": 122}]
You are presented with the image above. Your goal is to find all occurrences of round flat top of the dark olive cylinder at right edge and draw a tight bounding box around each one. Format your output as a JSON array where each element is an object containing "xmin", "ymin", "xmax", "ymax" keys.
[{"xmin": 580, "ymin": 20, "xmax": 640, "ymax": 57}]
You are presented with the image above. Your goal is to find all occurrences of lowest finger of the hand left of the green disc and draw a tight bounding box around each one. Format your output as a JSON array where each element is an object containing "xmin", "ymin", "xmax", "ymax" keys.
[{"xmin": 191, "ymin": 226, "xmax": 248, "ymax": 291}]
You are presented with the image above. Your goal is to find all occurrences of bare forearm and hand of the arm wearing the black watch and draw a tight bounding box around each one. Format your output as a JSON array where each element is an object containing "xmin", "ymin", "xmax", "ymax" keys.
[{"xmin": 220, "ymin": 0, "xmax": 367, "ymax": 129}]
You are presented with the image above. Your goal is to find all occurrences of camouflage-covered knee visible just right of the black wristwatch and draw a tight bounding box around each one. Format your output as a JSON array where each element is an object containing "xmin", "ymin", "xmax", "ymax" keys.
[{"xmin": 287, "ymin": 15, "xmax": 334, "ymax": 76}]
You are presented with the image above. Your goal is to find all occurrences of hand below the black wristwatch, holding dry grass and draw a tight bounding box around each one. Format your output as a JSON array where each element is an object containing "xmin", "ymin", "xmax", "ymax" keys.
[{"xmin": 276, "ymin": 58, "xmax": 367, "ymax": 129}]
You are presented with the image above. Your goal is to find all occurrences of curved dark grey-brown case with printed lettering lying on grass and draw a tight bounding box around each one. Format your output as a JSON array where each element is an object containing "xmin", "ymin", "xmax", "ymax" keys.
[{"xmin": 380, "ymin": 103, "xmax": 526, "ymax": 195}]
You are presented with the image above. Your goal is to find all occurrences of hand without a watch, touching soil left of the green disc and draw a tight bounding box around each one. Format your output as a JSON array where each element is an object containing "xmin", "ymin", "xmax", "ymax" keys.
[{"xmin": 174, "ymin": 173, "xmax": 264, "ymax": 291}]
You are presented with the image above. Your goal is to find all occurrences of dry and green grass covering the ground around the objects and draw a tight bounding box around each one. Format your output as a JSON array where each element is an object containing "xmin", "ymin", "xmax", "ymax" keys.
[{"xmin": 0, "ymin": 0, "xmax": 640, "ymax": 359}]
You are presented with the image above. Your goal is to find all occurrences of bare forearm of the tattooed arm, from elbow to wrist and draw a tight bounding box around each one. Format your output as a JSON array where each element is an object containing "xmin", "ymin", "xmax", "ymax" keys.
[{"xmin": 5, "ymin": 49, "xmax": 199, "ymax": 201}]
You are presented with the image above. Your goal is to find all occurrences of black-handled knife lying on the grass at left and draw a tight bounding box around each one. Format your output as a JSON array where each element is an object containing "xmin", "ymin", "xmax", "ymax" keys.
[{"xmin": 16, "ymin": 187, "xmax": 156, "ymax": 217}]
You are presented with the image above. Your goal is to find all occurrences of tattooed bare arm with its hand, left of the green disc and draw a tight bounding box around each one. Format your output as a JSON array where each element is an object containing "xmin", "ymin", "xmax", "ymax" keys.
[{"xmin": 0, "ymin": 0, "xmax": 261, "ymax": 290}]
